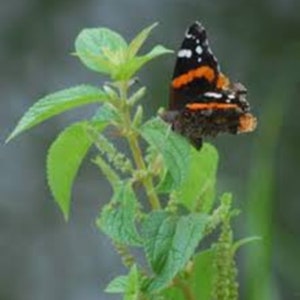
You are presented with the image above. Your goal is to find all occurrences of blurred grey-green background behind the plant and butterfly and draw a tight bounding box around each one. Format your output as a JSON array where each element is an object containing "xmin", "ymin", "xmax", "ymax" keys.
[{"xmin": 0, "ymin": 0, "xmax": 300, "ymax": 300}]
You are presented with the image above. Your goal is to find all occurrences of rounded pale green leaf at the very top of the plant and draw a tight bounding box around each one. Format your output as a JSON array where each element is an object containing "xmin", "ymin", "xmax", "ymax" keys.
[{"xmin": 75, "ymin": 28, "xmax": 127, "ymax": 74}]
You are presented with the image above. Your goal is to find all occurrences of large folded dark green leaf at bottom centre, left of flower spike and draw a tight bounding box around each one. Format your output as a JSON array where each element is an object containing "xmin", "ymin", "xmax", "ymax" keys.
[{"xmin": 142, "ymin": 211, "xmax": 208, "ymax": 292}]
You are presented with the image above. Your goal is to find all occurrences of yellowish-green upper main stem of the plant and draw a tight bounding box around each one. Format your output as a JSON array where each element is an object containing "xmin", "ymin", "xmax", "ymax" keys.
[{"xmin": 119, "ymin": 81, "xmax": 161, "ymax": 209}]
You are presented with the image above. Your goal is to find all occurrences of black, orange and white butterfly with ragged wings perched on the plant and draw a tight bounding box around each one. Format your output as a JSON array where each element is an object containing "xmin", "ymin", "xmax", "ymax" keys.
[{"xmin": 163, "ymin": 22, "xmax": 256, "ymax": 149}]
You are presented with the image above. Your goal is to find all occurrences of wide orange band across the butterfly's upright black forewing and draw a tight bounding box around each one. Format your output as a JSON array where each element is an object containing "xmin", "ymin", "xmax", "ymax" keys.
[{"xmin": 172, "ymin": 66, "xmax": 215, "ymax": 89}]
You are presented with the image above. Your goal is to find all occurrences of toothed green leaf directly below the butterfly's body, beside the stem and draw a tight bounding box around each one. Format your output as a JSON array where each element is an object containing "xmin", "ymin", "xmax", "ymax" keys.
[{"xmin": 140, "ymin": 118, "xmax": 192, "ymax": 189}]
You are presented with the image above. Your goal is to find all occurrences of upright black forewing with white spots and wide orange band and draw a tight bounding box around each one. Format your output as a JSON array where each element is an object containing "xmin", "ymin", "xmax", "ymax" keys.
[{"xmin": 169, "ymin": 22, "xmax": 228, "ymax": 110}]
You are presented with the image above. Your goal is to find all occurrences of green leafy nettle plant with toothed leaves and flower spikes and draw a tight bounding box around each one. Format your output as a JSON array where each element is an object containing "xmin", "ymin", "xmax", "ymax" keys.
[{"xmin": 8, "ymin": 24, "xmax": 254, "ymax": 300}]
